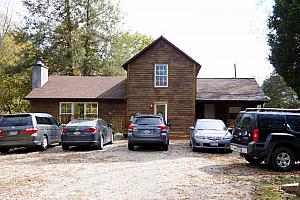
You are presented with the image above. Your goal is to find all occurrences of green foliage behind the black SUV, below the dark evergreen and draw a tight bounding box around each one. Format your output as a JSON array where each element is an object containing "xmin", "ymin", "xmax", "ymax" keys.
[{"xmin": 262, "ymin": 74, "xmax": 300, "ymax": 108}]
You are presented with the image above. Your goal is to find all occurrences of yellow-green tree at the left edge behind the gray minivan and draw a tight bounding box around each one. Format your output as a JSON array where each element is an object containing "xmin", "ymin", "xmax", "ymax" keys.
[{"xmin": 0, "ymin": 33, "xmax": 32, "ymax": 113}]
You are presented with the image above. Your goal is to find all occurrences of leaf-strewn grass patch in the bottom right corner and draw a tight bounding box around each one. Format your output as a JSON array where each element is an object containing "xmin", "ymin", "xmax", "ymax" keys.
[{"xmin": 253, "ymin": 176, "xmax": 300, "ymax": 200}]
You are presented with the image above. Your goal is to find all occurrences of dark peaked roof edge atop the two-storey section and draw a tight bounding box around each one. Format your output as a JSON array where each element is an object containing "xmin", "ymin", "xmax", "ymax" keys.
[{"xmin": 122, "ymin": 36, "xmax": 201, "ymax": 73}]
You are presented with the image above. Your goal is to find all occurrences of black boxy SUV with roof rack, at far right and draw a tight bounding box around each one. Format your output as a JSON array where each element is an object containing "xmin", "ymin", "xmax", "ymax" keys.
[{"xmin": 230, "ymin": 108, "xmax": 300, "ymax": 171}]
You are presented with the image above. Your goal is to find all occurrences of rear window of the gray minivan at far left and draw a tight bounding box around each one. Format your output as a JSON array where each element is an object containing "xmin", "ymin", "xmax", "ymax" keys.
[{"xmin": 0, "ymin": 115, "xmax": 32, "ymax": 127}]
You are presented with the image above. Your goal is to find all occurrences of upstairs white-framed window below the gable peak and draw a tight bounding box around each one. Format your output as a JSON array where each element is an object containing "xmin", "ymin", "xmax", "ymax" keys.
[{"xmin": 154, "ymin": 64, "xmax": 168, "ymax": 87}]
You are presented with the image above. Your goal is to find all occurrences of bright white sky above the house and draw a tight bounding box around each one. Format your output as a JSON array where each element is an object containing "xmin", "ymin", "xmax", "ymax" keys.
[{"xmin": 0, "ymin": 0, "xmax": 273, "ymax": 84}]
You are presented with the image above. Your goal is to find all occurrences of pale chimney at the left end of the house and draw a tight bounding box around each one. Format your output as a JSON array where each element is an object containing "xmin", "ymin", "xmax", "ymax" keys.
[{"xmin": 32, "ymin": 60, "xmax": 48, "ymax": 89}]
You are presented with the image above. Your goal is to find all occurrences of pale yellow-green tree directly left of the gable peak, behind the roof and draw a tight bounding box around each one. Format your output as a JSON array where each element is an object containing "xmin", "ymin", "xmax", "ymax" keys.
[{"xmin": 98, "ymin": 32, "xmax": 153, "ymax": 76}]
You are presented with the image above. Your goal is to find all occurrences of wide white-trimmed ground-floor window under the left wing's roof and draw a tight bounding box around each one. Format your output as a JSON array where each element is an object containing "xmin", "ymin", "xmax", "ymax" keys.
[{"xmin": 59, "ymin": 102, "xmax": 98, "ymax": 122}]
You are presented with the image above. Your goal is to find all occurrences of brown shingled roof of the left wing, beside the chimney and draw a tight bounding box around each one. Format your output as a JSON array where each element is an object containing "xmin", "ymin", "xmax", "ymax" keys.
[{"xmin": 25, "ymin": 76, "xmax": 127, "ymax": 99}]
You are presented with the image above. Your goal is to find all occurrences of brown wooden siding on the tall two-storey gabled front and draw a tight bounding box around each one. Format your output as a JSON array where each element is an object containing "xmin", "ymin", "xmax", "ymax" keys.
[{"xmin": 127, "ymin": 41, "xmax": 196, "ymax": 134}]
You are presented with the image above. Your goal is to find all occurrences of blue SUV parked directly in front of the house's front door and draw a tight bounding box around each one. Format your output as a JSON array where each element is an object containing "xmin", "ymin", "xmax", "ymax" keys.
[{"xmin": 128, "ymin": 115, "xmax": 170, "ymax": 151}]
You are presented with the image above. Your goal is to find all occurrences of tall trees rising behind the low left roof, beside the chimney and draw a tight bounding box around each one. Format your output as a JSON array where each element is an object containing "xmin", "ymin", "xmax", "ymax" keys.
[{"xmin": 23, "ymin": 0, "xmax": 120, "ymax": 75}]
